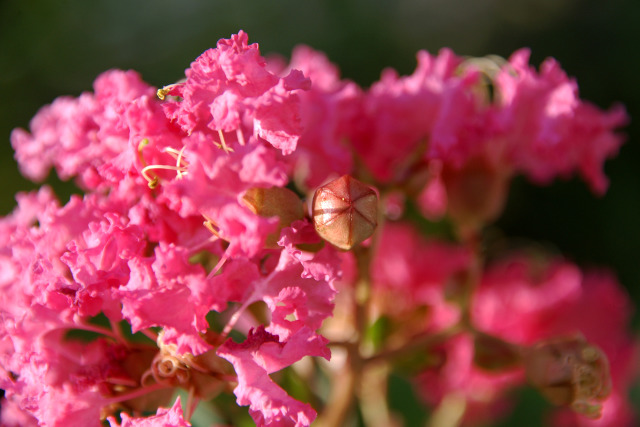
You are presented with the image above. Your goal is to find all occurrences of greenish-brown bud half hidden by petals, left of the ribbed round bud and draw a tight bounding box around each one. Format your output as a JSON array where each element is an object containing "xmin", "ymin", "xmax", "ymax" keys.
[{"xmin": 242, "ymin": 187, "xmax": 304, "ymax": 249}]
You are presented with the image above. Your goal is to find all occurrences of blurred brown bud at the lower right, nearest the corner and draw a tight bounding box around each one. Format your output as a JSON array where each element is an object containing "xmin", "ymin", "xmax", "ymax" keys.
[{"xmin": 525, "ymin": 337, "xmax": 611, "ymax": 418}]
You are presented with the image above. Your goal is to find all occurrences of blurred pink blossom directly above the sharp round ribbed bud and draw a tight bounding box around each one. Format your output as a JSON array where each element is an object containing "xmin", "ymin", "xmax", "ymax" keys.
[{"xmin": 269, "ymin": 46, "xmax": 362, "ymax": 189}]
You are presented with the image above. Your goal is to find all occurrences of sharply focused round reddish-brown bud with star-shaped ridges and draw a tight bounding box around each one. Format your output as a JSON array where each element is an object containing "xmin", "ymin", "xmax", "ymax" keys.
[{"xmin": 312, "ymin": 175, "xmax": 378, "ymax": 251}]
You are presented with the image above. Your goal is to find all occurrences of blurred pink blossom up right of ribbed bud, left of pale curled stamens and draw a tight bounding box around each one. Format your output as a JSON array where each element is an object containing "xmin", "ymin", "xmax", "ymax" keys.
[{"xmin": 352, "ymin": 49, "xmax": 485, "ymax": 182}]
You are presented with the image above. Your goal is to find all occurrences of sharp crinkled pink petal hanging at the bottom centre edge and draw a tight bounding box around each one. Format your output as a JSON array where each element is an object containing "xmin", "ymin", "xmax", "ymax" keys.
[{"xmin": 218, "ymin": 328, "xmax": 320, "ymax": 427}]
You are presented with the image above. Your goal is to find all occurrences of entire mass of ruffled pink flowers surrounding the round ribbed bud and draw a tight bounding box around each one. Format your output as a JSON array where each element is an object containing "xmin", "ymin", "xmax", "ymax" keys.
[{"xmin": 0, "ymin": 32, "xmax": 635, "ymax": 427}]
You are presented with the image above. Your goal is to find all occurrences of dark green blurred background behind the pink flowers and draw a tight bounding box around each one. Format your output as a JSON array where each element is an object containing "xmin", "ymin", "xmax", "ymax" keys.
[{"xmin": 0, "ymin": 0, "xmax": 640, "ymax": 426}]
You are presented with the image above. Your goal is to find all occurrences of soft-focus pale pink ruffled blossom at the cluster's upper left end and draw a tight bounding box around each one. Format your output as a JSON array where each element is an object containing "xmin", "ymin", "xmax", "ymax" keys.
[{"xmin": 11, "ymin": 70, "xmax": 154, "ymax": 188}]
